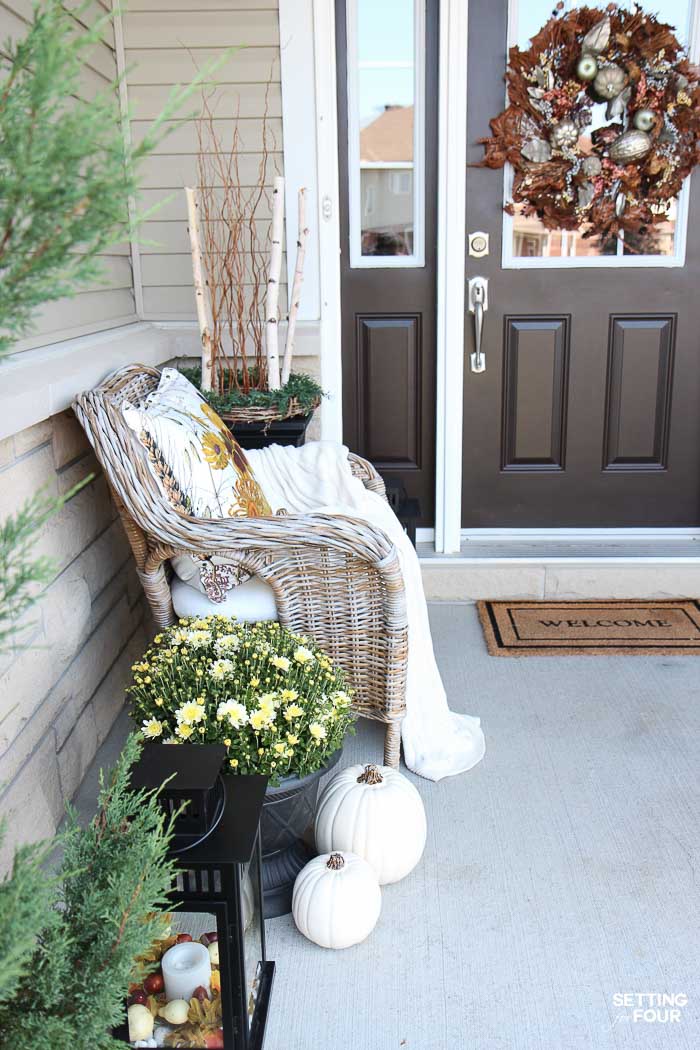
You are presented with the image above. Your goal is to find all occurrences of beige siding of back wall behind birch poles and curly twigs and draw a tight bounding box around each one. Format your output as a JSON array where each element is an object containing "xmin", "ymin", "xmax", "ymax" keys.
[{"xmin": 124, "ymin": 0, "xmax": 287, "ymax": 320}]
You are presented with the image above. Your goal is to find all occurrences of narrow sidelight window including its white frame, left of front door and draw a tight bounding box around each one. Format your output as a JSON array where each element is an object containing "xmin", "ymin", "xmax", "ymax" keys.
[{"xmin": 347, "ymin": 0, "xmax": 425, "ymax": 267}]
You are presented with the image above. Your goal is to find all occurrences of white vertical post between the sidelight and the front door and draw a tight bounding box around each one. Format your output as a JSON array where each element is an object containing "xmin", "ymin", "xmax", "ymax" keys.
[{"xmin": 434, "ymin": 0, "xmax": 468, "ymax": 554}]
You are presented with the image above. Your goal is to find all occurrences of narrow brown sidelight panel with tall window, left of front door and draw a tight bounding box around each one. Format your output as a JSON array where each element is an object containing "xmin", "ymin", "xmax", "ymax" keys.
[{"xmin": 336, "ymin": 0, "xmax": 438, "ymax": 525}]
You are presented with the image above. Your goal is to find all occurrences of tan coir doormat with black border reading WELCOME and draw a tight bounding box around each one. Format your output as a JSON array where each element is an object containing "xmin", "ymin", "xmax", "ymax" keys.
[{"xmin": 478, "ymin": 600, "xmax": 700, "ymax": 656}]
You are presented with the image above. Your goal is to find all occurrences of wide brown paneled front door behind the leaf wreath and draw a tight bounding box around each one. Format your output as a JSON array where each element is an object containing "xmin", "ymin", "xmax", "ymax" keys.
[{"xmin": 463, "ymin": 0, "xmax": 700, "ymax": 528}]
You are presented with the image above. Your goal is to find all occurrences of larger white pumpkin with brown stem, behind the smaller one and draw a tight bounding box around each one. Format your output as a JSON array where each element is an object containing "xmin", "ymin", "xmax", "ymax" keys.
[{"xmin": 316, "ymin": 765, "xmax": 427, "ymax": 886}]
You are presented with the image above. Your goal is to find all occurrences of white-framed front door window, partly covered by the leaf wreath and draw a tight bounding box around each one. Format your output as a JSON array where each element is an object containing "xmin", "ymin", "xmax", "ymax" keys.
[{"xmin": 507, "ymin": 0, "xmax": 691, "ymax": 258}]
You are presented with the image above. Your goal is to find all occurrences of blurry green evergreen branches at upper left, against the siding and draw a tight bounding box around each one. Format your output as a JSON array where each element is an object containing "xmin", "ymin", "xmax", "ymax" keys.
[{"xmin": 0, "ymin": 0, "xmax": 223, "ymax": 355}]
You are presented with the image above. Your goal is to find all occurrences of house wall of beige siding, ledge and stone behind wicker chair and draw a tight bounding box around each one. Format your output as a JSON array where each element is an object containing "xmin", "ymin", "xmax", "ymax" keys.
[{"xmin": 0, "ymin": 0, "xmax": 321, "ymax": 872}]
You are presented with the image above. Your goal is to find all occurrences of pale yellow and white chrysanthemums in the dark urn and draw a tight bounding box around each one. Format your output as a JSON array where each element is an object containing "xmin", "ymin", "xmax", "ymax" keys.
[{"xmin": 128, "ymin": 615, "xmax": 354, "ymax": 784}]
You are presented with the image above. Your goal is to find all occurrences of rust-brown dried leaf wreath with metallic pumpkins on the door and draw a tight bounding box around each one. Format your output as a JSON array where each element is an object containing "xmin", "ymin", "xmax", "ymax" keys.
[{"xmin": 480, "ymin": 3, "xmax": 700, "ymax": 237}]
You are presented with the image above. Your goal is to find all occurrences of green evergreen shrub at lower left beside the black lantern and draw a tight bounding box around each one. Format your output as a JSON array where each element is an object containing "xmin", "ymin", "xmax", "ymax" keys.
[{"xmin": 0, "ymin": 733, "xmax": 179, "ymax": 1050}]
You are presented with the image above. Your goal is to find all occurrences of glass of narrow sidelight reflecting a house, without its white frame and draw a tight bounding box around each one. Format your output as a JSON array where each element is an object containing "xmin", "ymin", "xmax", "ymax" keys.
[{"xmin": 348, "ymin": 0, "xmax": 416, "ymax": 256}]
